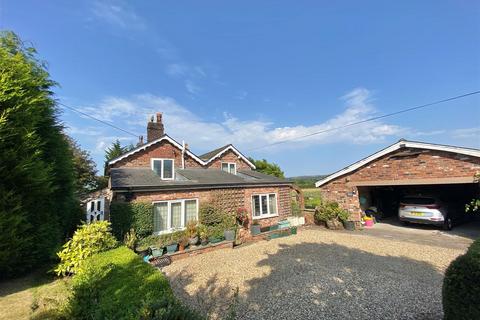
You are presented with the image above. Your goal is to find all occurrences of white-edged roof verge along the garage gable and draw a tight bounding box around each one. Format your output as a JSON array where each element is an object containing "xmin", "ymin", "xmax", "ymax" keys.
[{"xmin": 315, "ymin": 139, "xmax": 480, "ymax": 188}]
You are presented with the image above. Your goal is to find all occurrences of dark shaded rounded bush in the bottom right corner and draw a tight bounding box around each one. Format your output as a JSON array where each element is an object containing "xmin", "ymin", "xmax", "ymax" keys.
[{"xmin": 442, "ymin": 238, "xmax": 480, "ymax": 320}]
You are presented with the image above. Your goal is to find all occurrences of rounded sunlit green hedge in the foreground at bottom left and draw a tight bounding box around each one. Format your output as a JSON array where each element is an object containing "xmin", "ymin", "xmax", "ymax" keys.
[{"xmin": 67, "ymin": 247, "xmax": 200, "ymax": 319}]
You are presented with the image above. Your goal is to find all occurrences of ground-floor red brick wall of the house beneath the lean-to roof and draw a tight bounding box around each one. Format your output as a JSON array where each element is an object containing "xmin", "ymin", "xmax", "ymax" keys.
[{"xmin": 126, "ymin": 186, "xmax": 292, "ymax": 232}]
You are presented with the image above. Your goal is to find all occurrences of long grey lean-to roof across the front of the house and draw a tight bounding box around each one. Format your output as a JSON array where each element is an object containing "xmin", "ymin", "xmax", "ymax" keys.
[{"xmin": 110, "ymin": 168, "xmax": 286, "ymax": 190}]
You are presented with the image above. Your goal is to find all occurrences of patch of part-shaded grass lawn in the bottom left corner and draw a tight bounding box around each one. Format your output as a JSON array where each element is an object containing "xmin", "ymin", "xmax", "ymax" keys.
[{"xmin": 0, "ymin": 271, "xmax": 68, "ymax": 320}]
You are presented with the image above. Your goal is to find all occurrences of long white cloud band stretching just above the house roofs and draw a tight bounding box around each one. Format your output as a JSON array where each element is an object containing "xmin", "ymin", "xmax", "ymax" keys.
[{"xmin": 76, "ymin": 88, "xmax": 406, "ymax": 152}]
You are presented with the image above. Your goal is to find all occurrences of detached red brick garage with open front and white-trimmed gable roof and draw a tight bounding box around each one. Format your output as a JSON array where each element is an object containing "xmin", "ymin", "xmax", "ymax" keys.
[{"xmin": 316, "ymin": 140, "xmax": 480, "ymax": 230}]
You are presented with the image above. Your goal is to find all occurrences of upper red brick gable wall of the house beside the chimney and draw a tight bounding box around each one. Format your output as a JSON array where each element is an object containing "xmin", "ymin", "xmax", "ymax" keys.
[{"xmin": 112, "ymin": 141, "xmax": 201, "ymax": 168}]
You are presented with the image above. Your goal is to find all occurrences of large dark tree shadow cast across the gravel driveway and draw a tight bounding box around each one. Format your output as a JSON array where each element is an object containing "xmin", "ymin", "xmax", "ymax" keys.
[{"xmin": 171, "ymin": 243, "xmax": 443, "ymax": 319}]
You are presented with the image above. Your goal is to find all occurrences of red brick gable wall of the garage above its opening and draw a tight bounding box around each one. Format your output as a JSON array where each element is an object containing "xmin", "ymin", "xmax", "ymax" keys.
[{"xmin": 320, "ymin": 149, "xmax": 480, "ymax": 219}]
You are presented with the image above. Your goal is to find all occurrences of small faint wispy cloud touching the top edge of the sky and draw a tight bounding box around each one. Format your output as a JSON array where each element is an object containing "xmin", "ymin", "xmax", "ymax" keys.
[{"xmin": 91, "ymin": 0, "xmax": 146, "ymax": 30}]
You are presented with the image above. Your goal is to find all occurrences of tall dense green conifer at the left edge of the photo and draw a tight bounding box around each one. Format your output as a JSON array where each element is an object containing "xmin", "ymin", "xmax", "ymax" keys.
[{"xmin": 0, "ymin": 32, "xmax": 78, "ymax": 277}]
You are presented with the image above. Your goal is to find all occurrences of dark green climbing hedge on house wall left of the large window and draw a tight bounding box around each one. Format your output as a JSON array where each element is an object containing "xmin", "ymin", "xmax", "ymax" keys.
[{"xmin": 110, "ymin": 202, "xmax": 153, "ymax": 241}]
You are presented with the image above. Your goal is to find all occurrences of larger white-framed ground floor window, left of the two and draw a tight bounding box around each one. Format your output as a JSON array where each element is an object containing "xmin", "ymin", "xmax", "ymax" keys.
[{"xmin": 153, "ymin": 199, "xmax": 198, "ymax": 234}]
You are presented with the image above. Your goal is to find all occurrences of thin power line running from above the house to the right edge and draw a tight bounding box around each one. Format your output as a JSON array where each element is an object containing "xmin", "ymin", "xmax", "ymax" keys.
[{"xmin": 247, "ymin": 90, "xmax": 480, "ymax": 151}]
